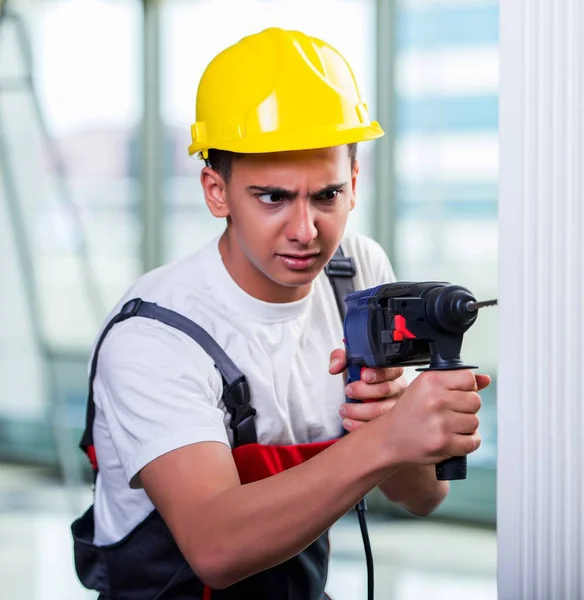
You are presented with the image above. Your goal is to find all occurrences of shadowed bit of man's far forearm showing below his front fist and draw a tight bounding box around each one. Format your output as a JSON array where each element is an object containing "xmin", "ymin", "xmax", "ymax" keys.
[{"xmin": 379, "ymin": 465, "xmax": 450, "ymax": 516}]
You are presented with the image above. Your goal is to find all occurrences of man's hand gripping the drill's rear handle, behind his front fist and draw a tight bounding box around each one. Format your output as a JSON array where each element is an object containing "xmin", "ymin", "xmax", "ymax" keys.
[{"xmin": 329, "ymin": 348, "xmax": 408, "ymax": 431}]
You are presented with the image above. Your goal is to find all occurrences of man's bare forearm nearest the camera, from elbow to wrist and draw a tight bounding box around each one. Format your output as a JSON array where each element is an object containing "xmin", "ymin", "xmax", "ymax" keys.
[{"xmin": 187, "ymin": 424, "xmax": 399, "ymax": 587}]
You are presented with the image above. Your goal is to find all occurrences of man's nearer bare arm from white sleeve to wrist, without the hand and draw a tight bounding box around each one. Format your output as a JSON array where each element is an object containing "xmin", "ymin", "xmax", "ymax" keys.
[{"xmin": 140, "ymin": 412, "xmax": 399, "ymax": 589}]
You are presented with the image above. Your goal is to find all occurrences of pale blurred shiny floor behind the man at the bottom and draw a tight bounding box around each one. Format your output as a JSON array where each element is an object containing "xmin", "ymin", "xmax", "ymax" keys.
[{"xmin": 0, "ymin": 466, "xmax": 497, "ymax": 600}]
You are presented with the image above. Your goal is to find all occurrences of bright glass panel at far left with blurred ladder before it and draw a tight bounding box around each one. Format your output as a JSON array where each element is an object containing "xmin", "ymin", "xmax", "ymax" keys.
[{"xmin": 0, "ymin": 0, "xmax": 141, "ymax": 436}]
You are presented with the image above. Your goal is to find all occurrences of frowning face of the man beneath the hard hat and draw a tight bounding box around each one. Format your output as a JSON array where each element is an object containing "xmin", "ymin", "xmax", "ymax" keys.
[{"xmin": 201, "ymin": 146, "xmax": 357, "ymax": 301}]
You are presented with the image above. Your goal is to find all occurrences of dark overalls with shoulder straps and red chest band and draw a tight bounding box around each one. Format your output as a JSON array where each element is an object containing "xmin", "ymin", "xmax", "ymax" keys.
[{"xmin": 71, "ymin": 248, "xmax": 355, "ymax": 600}]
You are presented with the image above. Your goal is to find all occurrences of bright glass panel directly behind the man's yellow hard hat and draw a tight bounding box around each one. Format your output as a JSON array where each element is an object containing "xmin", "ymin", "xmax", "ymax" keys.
[{"xmin": 161, "ymin": 0, "xmax": 375, "ymax": 259}]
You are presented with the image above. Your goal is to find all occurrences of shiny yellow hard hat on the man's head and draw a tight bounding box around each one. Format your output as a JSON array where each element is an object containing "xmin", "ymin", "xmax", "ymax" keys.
[{"xmin": 189, "ymin": 27, "xmax": 384, "ymax": 158}]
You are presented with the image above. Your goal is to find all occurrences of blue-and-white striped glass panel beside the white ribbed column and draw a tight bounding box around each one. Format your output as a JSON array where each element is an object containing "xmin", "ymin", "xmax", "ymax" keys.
[{"xmin": 395, "ymin": 0, "xmax": 499, "ymax": 478}]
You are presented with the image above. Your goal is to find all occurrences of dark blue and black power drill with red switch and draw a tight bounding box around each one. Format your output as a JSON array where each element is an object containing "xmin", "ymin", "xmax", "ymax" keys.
[{"xmin": 344, "ymin": 281, "xmax": 497, "ymax": 481}]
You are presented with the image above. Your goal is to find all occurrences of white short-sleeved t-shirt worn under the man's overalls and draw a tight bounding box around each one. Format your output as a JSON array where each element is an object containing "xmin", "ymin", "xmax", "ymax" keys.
[{"xmin": 93, "ymin": 235, "xmax": 395, "ymax": 545}]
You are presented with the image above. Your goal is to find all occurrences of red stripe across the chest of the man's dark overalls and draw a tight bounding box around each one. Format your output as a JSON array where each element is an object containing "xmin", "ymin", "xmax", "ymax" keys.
[{"xmin": 203, "ymin": 439, "xmax": 337, "ymax": 600}]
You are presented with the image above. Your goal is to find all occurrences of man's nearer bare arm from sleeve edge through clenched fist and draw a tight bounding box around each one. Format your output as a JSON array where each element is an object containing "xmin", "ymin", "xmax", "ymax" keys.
[{"xmin": 139, "ymin": 371, "xmax": 480, "ymax": 588}]
